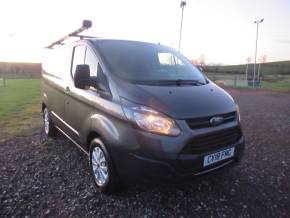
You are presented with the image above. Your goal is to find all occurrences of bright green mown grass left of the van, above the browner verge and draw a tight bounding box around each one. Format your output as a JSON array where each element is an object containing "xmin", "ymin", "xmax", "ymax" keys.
[{"xmin": 0, "ymin": 79, "xmax": 41, "ymax": 119}]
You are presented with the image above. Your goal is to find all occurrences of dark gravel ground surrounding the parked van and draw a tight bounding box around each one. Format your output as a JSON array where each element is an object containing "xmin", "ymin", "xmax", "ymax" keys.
[{"xmin": 0, "ymin": 87, "xmax": 290, "ymax": 218}]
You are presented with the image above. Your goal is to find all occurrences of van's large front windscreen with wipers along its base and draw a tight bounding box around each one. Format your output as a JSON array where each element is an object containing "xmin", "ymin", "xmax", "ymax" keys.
[{"xmin": 96, "ymin": 40, "xmax": 206, "ymax": 84}]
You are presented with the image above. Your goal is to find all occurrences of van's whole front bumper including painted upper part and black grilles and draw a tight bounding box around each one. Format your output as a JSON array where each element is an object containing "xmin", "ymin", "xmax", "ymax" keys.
[{"xmin": 106, "ymin": 113, "xmax": 245, "ymax": 181}]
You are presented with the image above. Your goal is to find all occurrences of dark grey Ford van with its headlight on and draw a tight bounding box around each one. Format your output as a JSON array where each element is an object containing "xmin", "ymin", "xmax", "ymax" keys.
[{"xmin": 42, "ymin": 38, "xmax": 245, "ymax": 193}]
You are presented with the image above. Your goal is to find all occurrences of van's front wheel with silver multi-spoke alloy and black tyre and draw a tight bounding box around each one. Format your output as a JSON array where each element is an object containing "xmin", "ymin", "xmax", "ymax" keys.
[{"xmin": 90, "ymin": 139, "xmax": 120, "ymax": 194}]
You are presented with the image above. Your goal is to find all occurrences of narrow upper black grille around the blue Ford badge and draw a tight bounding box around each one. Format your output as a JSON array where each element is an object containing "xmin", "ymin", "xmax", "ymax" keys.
[{"xmin": 186, "ymin": 111, "xmax": 237, "ymax": 129}]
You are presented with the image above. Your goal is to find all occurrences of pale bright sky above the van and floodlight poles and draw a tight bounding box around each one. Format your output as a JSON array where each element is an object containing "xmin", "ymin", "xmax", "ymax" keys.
[{"xmin": 0, "ymin": 0, "xmax": 290, "ymax": 64}]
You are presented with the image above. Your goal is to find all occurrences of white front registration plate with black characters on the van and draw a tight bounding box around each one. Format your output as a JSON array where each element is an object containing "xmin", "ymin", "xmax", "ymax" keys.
[{"xmin": 203, "ymin": 147, "xmax": 235, "ymax": 167}]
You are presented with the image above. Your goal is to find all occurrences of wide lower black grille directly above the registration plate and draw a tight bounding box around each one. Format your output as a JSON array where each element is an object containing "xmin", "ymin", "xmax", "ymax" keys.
[{"xmin": 182, "ymin": 127, "xmax": 242, "ymax": 154}]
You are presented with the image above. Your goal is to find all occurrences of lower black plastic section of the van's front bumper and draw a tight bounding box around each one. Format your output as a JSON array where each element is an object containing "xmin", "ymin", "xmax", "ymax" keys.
[{"xmin": 113, "ymin": 136, "xmax": 245, "ymax": 183}]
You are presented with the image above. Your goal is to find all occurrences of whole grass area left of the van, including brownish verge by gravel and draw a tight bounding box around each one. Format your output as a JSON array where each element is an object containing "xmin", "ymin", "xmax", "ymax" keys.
[{"xmin": 0, "ymin": 79, "xmax": 41, "ymax": 139}]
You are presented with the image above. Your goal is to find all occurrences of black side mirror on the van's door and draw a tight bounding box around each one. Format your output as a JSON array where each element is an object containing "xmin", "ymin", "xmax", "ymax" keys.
[{"xmin": 74, "ymin": 64, "xmax": 91, "ymax": 89}]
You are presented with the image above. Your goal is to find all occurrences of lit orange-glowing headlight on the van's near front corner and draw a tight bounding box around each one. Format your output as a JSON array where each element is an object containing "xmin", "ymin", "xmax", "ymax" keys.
[{"xmin": 124, "ymin": 106, "xmax": 180, "ymax": 136}]
